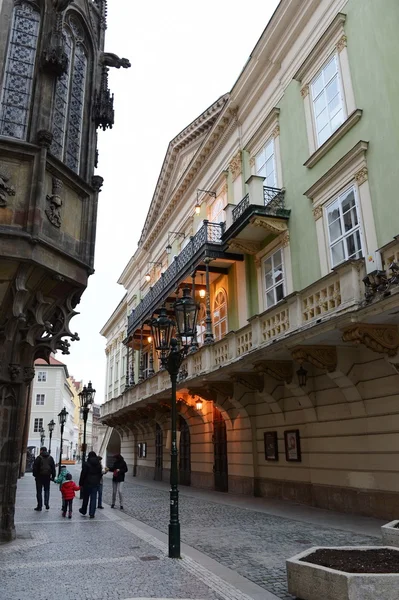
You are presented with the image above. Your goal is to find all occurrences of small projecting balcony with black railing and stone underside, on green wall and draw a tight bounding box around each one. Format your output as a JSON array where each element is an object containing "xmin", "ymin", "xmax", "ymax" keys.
[{"xmin": 222, "ymin": 175, "xmax": 290, "ymax": 254}]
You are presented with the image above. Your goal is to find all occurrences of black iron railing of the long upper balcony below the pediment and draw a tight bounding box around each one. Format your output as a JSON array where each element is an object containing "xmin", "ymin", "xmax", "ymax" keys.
[{"xmin": 128, "ymin": 221, "xmax": 224, "ymax": 333}]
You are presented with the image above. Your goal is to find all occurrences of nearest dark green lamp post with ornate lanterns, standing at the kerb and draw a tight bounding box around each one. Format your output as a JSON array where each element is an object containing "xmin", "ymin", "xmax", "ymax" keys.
[{"xmin": 151, "ymin": 288, "xmax": 199, "ymax": 558}]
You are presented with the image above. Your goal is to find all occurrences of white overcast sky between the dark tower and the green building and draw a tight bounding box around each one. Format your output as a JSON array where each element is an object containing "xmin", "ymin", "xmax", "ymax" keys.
[{"xmin": 63, "ymin": 0, "xmax": 278, "ymax": 403}]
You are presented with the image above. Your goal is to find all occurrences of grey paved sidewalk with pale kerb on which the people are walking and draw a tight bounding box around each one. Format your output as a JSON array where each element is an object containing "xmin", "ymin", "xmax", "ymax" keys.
[{"xmin": 0, "ymin": 469, "xmax": 276, "ymax": 600}]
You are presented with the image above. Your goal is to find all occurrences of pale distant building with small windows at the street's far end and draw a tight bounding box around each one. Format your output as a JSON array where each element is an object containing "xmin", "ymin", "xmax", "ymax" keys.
[{"xmin": 28, "ymin": 356, "xmax": 78, "ymax": 462}]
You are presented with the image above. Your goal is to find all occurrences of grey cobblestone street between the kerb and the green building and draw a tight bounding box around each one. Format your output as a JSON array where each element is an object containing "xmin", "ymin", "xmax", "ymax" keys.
[{"xmin": 104, "ymin": 476, "xmax": 380, "ymax": 600}]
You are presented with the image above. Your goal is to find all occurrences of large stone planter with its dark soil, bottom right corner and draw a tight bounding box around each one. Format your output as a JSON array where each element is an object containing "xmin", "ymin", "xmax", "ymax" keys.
[{"xmin": 287, "ymin": 546, "xmax": 399, "ymax": 600}]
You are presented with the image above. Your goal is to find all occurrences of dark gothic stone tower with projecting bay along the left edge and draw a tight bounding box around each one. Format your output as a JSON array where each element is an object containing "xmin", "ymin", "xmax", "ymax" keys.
[{"xmin": 0, "ymin": 0, "xmax": 130, "ymax": 541}]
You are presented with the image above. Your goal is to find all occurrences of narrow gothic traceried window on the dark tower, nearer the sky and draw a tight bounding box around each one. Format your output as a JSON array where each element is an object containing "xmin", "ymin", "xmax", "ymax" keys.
[{"xmin": 51, "ymin": 15, "xmax": 88, "ymax": 173}]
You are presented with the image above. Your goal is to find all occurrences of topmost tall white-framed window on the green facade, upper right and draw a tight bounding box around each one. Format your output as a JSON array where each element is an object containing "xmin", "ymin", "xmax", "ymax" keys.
[{"xmin": 311, "ymin": 55, "xmax": 345, "ymax": 146}]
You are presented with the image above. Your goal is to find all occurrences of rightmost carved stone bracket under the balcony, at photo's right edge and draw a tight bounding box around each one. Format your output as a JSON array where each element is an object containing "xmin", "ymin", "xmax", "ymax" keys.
[{"xmin": 342, "ymin": 323, "xmax": 399, "ymax": 356}]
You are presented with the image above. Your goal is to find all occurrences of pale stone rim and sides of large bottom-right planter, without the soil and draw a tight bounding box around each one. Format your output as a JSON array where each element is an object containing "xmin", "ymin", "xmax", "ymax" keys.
[{"xmin": 286, "ymin": 546, "xmax": 399, "ymax": 600}]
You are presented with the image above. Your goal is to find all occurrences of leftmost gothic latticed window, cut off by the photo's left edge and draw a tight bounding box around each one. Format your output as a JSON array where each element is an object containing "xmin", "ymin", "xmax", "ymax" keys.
[{"xmin": 0, "ymin": 1, "xmax": 40, "ymax": 140}]
